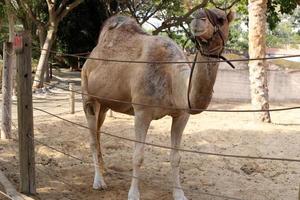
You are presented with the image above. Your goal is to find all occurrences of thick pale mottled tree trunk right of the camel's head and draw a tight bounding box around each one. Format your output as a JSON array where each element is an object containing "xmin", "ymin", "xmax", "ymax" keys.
[{"xmin": 248, "ymin": 0, "xmax": 271, "ymax": 122}]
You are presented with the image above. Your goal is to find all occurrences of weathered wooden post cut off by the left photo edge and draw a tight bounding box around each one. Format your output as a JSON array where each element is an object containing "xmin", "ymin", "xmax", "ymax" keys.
[{"xmin": 0, "ymin": 42, "xmax": 13, "ymax": 139}]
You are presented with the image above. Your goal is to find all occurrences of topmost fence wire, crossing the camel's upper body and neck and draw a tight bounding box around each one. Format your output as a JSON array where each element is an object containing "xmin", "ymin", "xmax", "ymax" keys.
[{"xmin": 33, "ymin": 47, "xmax": 300, "ymax": 64}]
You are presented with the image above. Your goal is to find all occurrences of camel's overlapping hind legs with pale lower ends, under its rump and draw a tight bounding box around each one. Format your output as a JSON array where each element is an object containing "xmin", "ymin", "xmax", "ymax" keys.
[{"xmin": 84, "ymin": 101, "xmax": 107, "ymax": 189}]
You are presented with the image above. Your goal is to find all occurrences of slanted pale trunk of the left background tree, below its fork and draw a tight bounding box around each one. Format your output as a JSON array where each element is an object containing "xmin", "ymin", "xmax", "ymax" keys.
[{"xmin": 33, "ymin": 27, "xmax": 57, "ymax": 89}]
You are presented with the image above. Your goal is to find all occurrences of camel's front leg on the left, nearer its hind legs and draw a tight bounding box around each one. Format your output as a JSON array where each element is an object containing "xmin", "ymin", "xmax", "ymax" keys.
[{"xmin": 128, "ymin": 111, "xmax": 151, "ymax": 200}]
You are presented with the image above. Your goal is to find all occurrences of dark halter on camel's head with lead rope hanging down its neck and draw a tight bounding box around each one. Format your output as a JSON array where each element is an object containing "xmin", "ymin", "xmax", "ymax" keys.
[{"xmin": 187, "ymin": 9, "xmax": 235, "ymax": 109}]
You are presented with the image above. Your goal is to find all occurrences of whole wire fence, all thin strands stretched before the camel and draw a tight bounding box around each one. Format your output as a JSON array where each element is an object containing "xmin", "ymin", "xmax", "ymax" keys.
[{"xmin": 0, "ymin": 45, "xmax": 300, "ymax": 200}]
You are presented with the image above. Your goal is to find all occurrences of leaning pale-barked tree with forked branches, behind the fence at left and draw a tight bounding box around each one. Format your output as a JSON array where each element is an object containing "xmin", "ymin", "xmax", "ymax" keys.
[{"xmin": 17, "ymin": 0, "xmax": 83, "ymax": 89}]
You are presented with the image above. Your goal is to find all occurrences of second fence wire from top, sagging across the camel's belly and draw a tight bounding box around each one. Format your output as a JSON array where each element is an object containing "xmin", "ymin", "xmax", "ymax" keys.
[{"xmin": 41, "ymin": 80, "xmax": 300, "ymax": 113}]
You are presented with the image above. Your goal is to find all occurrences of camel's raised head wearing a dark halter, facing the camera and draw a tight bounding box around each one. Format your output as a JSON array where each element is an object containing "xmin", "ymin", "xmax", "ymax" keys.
[{"xmin": 190, "ymin": 9, "xmax": 234, "ymax": 54}]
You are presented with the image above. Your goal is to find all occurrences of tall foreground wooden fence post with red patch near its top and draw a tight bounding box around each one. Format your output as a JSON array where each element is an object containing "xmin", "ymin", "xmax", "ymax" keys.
[{"xmin": 14, "ymin": 32, "xmax": 36, "ymax": 194}]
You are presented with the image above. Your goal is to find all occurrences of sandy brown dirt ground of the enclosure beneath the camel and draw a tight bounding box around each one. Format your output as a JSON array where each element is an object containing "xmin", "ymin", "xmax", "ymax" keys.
[{"xmin": 0, "ymin": 78, "xmax": 300, "ymax": 200}]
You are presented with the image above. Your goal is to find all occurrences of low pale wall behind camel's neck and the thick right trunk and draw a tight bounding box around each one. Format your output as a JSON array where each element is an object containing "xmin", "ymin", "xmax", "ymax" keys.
[{"xmin": 213, "ymin": 69, "xmax": 300, "ymax": 102}]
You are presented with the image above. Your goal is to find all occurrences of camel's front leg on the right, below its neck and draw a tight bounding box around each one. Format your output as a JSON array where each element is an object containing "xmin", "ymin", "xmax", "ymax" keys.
[{"xmin": 170, "ymin": 114, "xmax": 189, "ymax": 200}]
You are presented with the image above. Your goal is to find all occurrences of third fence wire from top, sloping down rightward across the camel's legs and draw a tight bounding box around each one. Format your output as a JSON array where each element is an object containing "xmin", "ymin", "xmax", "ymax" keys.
[{"xmin": 33, "ymin": 108, "xmax": 300, "ymax": 162}]
